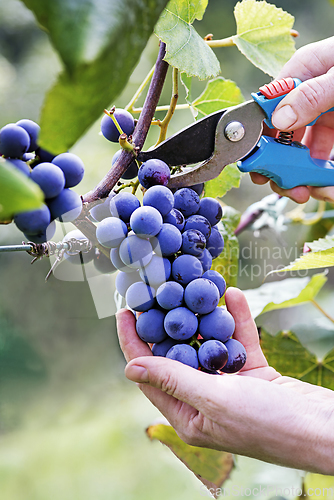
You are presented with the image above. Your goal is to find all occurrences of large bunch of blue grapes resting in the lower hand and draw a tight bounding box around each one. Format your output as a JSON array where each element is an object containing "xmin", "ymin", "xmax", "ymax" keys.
[{"xmin": 91, "ymin": 154, "xmax": 246, "ymax": 374}]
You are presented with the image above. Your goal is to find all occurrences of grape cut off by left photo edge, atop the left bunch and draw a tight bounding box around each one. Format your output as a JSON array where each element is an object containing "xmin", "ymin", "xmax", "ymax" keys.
[{"xmin": 0, "ymin": 123, "xmax": 30, "ymax": 158}]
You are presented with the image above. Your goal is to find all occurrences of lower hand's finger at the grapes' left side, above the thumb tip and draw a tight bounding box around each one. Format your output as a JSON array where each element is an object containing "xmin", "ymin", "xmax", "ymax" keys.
[{"xmin": 116, "ymin": 309, "xmax": 152, "ymax": 361}]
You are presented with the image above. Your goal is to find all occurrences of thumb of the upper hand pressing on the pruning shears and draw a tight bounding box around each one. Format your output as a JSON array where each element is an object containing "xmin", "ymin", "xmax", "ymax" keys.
[{"xmin": 272, "ymin": 72, "xmax": 334, "ymax": 130}]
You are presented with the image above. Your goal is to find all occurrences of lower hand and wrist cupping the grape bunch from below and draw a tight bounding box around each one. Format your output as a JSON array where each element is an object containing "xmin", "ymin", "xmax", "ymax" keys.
[{"xmin": 117, "ymin": 288, "xmax": 334, "ymax": 474}]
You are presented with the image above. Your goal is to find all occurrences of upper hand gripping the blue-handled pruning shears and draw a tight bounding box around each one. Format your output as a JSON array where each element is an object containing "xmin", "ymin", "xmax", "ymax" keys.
[{"xmin": 251, "ymin": 37, "xmax": 334, "ymax": 203}]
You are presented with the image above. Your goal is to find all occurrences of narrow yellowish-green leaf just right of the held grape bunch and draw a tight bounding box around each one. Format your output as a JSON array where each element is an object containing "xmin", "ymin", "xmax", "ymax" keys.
[{"xmin": 211, "ymin": 206, "xmax": 240, "ymax": 290}]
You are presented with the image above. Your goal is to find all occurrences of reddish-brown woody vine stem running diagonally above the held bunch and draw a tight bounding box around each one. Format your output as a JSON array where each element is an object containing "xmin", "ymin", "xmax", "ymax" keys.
[{"xmin": 83, "ymin": 42, "xmax": 168, "ymax": 203}]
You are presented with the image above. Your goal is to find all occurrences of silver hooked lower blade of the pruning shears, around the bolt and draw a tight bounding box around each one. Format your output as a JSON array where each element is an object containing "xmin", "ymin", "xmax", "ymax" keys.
[{"xmin": 168, "ymin": 100, "xmax": 266, "ymax": 188}]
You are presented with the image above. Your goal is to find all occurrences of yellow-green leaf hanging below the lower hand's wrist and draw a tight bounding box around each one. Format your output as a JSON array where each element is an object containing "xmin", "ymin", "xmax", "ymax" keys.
[{"xmin": 146, "ymin": 424, "xmax": 234, "ymax": 498}]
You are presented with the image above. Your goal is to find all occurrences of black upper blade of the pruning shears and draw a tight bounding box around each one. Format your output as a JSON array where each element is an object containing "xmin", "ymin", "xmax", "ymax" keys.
[{"xmin": 138, "ymin": 109, "xmax": 226, "ymax": 167}]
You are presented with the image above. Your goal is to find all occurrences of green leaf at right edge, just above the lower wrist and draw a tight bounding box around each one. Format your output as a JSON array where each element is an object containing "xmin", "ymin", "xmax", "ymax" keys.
[{"xmin": 261, "ymin": 329, "xmax": 334, "ymax": 390}]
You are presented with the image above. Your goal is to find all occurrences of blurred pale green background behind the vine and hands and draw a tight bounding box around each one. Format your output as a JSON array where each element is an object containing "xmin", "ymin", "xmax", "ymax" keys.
[{"xmin": 0, "ymin": 0, "xmax": 334, "ymax": 500}]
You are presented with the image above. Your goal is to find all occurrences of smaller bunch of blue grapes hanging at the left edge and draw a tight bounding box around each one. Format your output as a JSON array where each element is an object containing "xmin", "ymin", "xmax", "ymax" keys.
[{"xmin": 0, "ymin": 119, "xmax": 85, "ymax": 243}]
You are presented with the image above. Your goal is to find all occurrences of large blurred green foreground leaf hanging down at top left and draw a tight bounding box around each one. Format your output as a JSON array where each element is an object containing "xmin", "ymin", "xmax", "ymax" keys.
[{"xmin": 24, "ymin": 0, "xmax": 167, "ymax": 154}]
